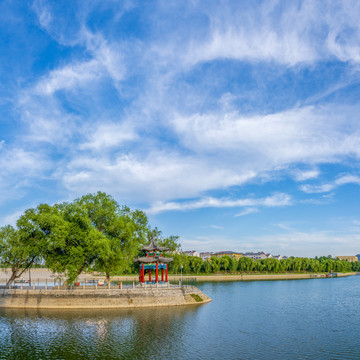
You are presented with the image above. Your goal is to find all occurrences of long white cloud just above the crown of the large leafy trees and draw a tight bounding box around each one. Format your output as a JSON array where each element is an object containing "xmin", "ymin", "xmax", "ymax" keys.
[{"xmin": 57, "ymin": 152, "xmax": 255, "ymax": 202}]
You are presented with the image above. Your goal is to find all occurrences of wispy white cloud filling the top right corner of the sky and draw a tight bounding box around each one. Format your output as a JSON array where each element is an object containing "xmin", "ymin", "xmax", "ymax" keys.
[{"xmin": 180, "ymin": 1, "xmax": 360, "ymax": 66}]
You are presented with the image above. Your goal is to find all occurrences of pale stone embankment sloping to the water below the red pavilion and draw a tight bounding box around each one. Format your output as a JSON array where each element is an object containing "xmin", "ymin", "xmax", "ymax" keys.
[{"xmin": 0, "ymin": 286, "xmax": 211, "ymax": 309}]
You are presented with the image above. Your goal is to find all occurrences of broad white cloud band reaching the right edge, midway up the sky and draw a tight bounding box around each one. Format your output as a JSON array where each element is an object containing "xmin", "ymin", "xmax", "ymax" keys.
[{"xmin": 173, "ymin": 106, "xmax": 360, "ymax": 167}]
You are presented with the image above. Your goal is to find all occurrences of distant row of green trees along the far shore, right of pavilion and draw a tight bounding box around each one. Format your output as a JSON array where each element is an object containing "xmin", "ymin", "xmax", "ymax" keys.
[{"xmin": 163, "ymin": 255, "xmax": 360, "ymax": 274}]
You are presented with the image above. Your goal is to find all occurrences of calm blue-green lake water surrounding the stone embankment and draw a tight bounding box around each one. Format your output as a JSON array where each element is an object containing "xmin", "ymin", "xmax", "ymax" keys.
[{"xmin": 0, "ymin": 276, "xmax": 360, "ymax": 359}]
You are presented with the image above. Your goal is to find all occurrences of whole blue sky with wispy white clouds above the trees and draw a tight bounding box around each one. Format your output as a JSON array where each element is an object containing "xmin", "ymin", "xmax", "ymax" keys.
[{"xmin": 0, "ymin": 0, "xmax": 360, "ymax": 256}]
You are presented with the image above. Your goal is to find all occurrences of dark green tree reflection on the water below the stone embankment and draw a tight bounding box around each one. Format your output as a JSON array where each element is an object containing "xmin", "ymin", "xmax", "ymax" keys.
[{"xmin": 0, "ymin": 306, "xmax": 197, "ymax": 359}]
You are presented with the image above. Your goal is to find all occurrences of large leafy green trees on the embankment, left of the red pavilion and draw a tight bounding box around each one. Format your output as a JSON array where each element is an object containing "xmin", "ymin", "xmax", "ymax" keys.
[{"xmin": 0, "ymin": 192, "xmax": 180, "ymax": 285}]
